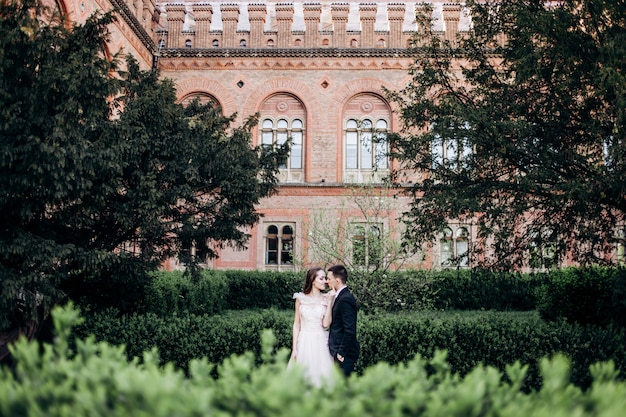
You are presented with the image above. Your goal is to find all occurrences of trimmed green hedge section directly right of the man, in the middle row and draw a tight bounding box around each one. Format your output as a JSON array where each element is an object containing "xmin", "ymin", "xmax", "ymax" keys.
[{"xmin": 359, "ymin": 312, "xmax": 626, "ymax": 389}]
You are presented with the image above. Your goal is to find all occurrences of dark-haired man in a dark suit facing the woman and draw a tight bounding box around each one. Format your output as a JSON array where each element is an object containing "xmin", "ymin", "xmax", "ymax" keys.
[{"xmin": 327, "ymin": 265, "xmax": 360, "ymax": 376}]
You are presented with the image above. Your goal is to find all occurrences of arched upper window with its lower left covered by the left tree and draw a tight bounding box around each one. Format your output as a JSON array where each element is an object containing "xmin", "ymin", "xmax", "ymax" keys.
[{"xmin": 259, "ymin": 94, "xmax": 306, "ymax": 182}]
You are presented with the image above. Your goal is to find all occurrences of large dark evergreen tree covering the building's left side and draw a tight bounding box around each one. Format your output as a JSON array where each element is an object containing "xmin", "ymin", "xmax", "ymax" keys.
[{"xmin": 0, "ymin": 0, "xmax": 285, "ymax": 329}]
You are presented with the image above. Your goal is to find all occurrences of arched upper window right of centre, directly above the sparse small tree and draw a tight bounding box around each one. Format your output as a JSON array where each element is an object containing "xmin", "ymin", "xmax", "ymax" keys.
[{"xmin": 343, "ymin": 94, "xmax": 391, "ymax": 183}]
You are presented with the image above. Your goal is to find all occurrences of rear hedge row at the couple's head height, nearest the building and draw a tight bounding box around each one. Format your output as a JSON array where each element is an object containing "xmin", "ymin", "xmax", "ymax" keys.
[{"xmin": 142, "ymin": 270, "xmax": 545, "ymax": 316}]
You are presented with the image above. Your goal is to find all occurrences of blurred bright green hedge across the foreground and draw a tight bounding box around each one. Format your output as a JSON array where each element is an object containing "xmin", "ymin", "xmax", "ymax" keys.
[{"xmin": 0, "ymin": 302, "xmax": 626, "ymax": 417}]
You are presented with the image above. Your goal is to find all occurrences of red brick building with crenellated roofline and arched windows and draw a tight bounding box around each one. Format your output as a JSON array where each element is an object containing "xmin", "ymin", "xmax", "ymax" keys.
[{"xmin": 47, "ymin": 0, "xmax": 474, "ymax": 270}]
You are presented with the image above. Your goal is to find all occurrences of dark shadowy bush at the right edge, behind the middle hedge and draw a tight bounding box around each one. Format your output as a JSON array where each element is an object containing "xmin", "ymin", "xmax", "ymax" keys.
[{"xmin": 537, "ymin": 267, "xmax": 626, "ymax": 326}]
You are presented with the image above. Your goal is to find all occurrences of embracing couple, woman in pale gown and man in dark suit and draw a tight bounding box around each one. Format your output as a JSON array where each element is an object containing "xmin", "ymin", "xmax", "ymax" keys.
[{"xmin": 289, "ymin": 265, "xmax": 359, "ymax": 386}]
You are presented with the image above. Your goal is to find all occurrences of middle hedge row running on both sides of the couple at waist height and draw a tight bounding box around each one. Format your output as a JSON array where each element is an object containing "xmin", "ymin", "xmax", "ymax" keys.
[{"xmin": 70, "ymin": 309, "xmax": 626, "ymax": 388}]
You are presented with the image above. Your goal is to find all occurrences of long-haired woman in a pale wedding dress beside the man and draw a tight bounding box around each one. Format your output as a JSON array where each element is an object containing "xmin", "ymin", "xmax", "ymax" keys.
[{"xmin": 288, "ymin": 268, "xmax": 334, "ymax": 387}]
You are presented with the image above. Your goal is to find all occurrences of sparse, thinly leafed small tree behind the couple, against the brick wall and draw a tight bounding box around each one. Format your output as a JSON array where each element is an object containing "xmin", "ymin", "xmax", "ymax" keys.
[{"xmin": 300, "ymin": 185, "xmax": 430, "ymax": 311}]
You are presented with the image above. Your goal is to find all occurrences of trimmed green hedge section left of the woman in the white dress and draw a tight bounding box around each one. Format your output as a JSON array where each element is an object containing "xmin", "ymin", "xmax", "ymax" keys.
[{"xmin": 74, "ymin": 310, "xmax": 293, "ymax": 369}]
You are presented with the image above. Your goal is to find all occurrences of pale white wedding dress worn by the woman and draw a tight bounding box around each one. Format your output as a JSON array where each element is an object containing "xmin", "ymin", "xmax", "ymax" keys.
[{"xmin": 288, "ymin": 292, "xmax": 334, "ymax": 387}]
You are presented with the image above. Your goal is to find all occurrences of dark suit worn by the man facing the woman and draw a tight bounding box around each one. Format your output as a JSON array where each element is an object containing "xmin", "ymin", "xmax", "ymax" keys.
[{"xmin": 328, "ymin": 288, "xmax": 360, "ymax": 376}]
